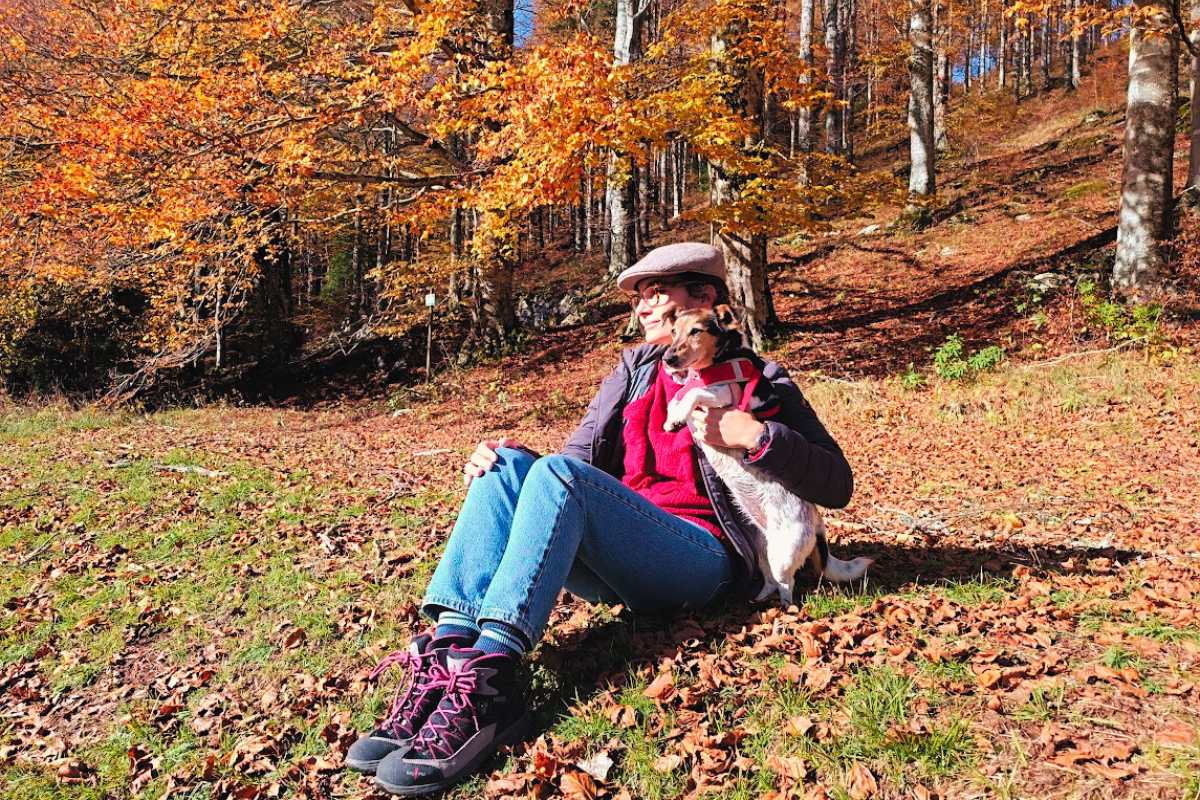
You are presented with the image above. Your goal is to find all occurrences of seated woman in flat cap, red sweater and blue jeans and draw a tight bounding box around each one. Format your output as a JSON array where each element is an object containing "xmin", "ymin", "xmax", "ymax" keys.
[{"xmin": 347, "ymin": 242, "xmax": 852, "ymax": 796}]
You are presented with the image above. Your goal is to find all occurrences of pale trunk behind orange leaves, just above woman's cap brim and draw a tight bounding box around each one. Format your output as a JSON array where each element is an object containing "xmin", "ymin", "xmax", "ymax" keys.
[{"xmin": 605, "ymin": 0, "xmax": 642, "ymax": 276}]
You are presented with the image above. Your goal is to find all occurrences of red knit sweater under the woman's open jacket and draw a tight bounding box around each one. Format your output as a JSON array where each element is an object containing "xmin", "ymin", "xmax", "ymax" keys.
[{"xmin": 622, "ymin": 365, "xmax": 722, "ymax": 539}]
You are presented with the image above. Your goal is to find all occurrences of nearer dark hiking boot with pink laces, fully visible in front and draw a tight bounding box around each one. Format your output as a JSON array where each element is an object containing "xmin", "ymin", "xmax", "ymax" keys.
[{"xmin": 376, "ymin": 646, "xmax": 532, "ymax": 796}]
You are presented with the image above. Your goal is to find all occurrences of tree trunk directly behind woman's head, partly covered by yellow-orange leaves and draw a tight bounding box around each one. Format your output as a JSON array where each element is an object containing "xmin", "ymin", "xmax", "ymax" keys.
[{"xmin": 708, "ymin": 21, "xmax": 768, "ymax": 348}]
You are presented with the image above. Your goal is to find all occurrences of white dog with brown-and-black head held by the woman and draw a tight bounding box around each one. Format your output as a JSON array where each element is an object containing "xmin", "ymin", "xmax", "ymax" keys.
[{"xmin": 662, "ymin": 305, "xmax": 872, "ymax": 607}]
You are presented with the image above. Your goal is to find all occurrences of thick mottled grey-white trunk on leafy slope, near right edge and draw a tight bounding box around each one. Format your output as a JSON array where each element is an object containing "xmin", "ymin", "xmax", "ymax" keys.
[{"xmin": 1112, "ymin": 2, "xmax": 1178, "ymax": 296}]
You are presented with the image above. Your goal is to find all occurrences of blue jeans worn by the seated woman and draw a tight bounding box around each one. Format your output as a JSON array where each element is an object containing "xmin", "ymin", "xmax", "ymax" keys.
[{"xmin": 421, "ymin": 447, "xmax": 733, "ymax": 643}]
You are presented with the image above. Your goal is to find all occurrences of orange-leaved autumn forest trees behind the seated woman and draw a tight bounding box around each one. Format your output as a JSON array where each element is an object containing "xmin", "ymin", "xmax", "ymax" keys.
[{"xmin": 0, "ymin": 0, "xmax": 1200, "ymax": 399}]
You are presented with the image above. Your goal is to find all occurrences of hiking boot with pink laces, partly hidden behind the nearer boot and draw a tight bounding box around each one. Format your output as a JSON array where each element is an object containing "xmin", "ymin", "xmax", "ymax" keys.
[{"xmin": 346, "ymin": 632, "xmax": 462, "ymax": 775}]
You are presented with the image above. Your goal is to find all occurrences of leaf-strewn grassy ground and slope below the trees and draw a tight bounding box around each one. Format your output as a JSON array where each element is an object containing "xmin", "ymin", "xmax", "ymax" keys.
[{"xmin": 7, "ymin": 56, "xmax": 1200, "ymax": 800}]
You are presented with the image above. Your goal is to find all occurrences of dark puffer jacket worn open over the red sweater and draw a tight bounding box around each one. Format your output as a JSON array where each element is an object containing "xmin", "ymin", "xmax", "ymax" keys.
[{"xmin": 563, "ymin": 344, "xmax": 854, "ymax": 593}]
